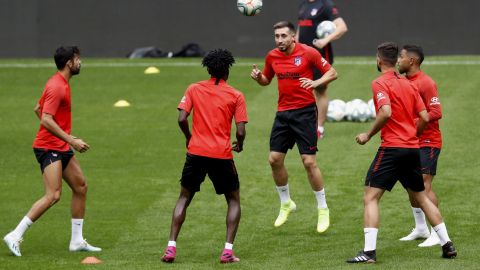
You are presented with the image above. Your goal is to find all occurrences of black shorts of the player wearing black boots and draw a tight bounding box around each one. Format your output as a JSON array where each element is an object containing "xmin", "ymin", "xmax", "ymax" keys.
[{"xmin": 365, "ymin": 147, "xmax": 425, "ymax": 192}]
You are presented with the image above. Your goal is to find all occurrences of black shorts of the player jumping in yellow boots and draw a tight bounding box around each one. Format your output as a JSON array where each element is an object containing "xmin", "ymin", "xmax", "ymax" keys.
[{"xmin": 270, "ymin": 104, "xmax": 318, "ymax": 155}]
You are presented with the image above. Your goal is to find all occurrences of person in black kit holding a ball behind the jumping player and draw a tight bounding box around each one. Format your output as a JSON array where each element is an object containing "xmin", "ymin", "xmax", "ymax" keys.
[{"xmin": 297, "ymin": 0, "xmax": 348, "ymax": 138}]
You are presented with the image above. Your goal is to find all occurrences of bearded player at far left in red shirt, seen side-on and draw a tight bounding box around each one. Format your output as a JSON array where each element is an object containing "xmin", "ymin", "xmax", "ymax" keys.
[{"xmin": 3, "ymin": 46, "xmax": 102, "ymax": 256}]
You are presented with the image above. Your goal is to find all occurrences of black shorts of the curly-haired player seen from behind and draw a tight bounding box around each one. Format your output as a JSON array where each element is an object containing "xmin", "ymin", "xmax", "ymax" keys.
[{"xmin": 180, "ymin": 153, "xmax": 240, "ymax": 194}]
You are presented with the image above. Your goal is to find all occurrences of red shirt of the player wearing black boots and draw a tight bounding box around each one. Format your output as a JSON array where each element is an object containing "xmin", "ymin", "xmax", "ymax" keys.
[{"xmin": 372, "ymin": 71, "xmax": 425, "ymax": 148}]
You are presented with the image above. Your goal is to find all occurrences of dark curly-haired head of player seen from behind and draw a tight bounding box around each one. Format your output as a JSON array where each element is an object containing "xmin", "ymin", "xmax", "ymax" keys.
[{"xmin": 202, "ymin": 49, "xmax": 235, "ymax": 81}]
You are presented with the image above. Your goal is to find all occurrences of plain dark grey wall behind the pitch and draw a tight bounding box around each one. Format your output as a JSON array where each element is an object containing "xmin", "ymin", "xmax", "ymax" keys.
[{"xmin": 0, "ymin": 0, "xmax": 480, "ymax": 58}]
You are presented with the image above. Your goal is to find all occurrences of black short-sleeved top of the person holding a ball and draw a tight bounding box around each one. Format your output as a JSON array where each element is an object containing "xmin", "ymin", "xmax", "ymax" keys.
[{"xmin": 298, "ymin": 0, "xmax": 340, "ymax": 64}]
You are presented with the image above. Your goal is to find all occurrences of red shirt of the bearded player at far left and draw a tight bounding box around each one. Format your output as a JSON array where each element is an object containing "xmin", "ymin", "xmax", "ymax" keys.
[{"xmin": 33, "ymin": 72, "xmax": 72, "ymax": 151}]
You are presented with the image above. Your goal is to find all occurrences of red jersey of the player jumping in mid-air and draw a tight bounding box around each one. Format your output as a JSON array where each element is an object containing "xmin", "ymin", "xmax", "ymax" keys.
[{"xmin": 263, "ymin": 43, "xmax": 331, "ymax": 111}]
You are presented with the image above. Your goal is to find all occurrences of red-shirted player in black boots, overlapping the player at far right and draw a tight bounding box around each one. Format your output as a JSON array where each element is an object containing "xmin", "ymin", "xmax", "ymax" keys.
[{"xmin": 347, "ymin": 42, "xmax": 457, "ymax": 263}]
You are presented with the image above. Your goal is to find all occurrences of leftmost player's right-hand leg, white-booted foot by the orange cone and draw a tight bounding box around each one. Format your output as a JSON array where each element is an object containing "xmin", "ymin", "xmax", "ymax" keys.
[{"xmin": 63, "ymin": 155, "xmax": 102, "ymax": 252}]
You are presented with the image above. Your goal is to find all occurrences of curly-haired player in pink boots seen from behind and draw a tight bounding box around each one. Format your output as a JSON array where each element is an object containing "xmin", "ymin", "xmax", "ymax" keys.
[{"xmin": 162, "ymin": 49, "xmax": 248, "ymax": 263}]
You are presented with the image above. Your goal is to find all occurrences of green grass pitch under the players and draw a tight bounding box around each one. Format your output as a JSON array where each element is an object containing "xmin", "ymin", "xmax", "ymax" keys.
[{"xmin": 0, "ymin": 56, "xmax": 480, "ymax": 269}]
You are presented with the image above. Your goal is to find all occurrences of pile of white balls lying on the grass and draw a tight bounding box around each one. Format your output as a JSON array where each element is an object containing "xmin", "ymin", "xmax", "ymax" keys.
[{"xmin": 327, "ymin": 99, "xmax": 375, "ymax": 122}]
